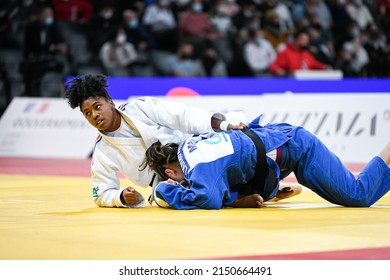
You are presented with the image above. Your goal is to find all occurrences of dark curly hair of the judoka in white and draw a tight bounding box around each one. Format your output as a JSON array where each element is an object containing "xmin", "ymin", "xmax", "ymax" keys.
[{"xmin": 65, "ymin": 74, "xmax": 112, "ymax": 110}]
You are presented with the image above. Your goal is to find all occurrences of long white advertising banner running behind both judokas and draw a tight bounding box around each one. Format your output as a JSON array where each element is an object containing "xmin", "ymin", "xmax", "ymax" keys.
[{"xmin": 0, "ymin": 92, "xmax": 390, "ymax": 163}]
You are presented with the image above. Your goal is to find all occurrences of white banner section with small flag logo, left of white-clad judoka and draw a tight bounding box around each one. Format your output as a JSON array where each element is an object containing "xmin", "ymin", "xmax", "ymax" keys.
[{"xmin": 0, "ymin": 97, "xmax": 97, "ymax": 159}]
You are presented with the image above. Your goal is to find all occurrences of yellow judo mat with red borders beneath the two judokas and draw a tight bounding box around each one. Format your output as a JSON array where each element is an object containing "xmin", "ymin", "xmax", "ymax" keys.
[{"xmin": 0, "ymin": 157, "xmax": 390, "ymax": 260}]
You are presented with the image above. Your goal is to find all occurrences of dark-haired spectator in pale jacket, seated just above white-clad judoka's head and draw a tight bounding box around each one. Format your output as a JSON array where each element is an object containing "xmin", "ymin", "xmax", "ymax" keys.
[{"xmin": 100, "ymin": 28, "xmax": 137, "ymax": 77}]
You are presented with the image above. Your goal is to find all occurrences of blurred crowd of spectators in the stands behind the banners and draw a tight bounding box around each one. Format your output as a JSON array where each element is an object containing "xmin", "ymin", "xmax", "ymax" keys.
[{"xmin": 0, "ymin": 0, "xmax": 390, "ymax": 100}]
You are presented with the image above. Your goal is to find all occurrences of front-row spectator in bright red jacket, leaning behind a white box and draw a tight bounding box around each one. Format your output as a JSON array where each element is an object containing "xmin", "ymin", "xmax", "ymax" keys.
[{"xmin": 269, "ymin": 30, "xmax": 330, "ymax": 76}]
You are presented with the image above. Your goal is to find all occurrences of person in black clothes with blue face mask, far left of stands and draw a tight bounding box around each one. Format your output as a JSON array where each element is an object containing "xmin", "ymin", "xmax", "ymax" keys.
[{"xmin": 20, "ymin": 6, "xmax": 68, "ymax": 96}]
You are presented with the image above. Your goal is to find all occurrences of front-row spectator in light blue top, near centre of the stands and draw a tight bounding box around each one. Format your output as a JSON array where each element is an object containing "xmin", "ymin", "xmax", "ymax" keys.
[{"xmin": 166, "ymin": 42, "xmax": 203, "ymax": 77}]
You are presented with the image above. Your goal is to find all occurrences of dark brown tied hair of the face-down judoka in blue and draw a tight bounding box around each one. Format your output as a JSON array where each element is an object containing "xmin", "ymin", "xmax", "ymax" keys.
[{"xmin": 140, "ymin": 141, "xmax": 179, "ymax": 180}]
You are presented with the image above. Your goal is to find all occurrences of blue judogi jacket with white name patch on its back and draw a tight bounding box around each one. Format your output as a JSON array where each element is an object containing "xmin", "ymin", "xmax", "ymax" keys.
[{"xmin": 155, "ymin": 117, "xmax": 293, "ymax": 209}]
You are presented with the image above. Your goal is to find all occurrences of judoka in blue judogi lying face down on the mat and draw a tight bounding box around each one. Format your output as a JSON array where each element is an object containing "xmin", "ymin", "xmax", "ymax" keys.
[{"xmin": 145, "ymin": 117, "xmax": 390, "ymax": 209}]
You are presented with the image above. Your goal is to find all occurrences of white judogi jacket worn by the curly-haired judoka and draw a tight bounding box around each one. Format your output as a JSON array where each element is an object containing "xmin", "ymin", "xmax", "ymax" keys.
[{"xmin": 91, "ymin": 97, "xmax": 225, "ymax": 207}]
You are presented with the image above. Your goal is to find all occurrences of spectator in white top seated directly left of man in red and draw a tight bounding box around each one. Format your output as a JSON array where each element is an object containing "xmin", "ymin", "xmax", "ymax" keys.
[{"xmin": 243, "ymin": 29, "xmax": 276, "ymax": 76}]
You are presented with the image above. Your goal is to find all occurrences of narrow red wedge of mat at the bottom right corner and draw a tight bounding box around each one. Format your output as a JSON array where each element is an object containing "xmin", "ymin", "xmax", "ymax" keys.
[{"xmin": 200, "ymin": 247, "xmax": 390, "ymax": 260}]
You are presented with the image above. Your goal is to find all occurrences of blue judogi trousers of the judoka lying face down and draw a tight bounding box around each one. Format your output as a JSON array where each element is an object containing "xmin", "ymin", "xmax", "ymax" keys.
[{"xmin": 280, "ymin": 128, "xmax": 390, "ymax": 207}]
